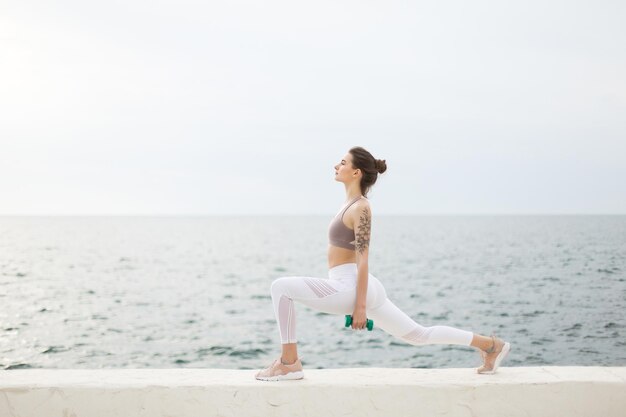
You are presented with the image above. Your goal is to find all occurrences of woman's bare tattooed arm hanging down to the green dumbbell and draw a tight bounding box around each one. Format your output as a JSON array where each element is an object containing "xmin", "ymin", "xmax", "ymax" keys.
[{"xmin": 352, "ymin": 204, "xmax": 372, "ymax": 329}]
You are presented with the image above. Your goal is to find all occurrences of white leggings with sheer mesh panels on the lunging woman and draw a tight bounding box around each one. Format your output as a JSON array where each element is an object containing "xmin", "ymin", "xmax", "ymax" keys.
[{"xmin": 271, "ymin": 263, "xmax": 474, "ymax": 346}]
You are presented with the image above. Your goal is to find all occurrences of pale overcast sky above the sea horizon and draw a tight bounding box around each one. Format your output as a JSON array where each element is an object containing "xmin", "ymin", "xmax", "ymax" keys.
[{"xmin": 0, "ymin": 0, "xmax": 626, "ymax": 215}]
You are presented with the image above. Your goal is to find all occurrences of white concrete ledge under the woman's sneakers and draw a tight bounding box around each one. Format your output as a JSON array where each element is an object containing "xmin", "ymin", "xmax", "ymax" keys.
[{"xmin": 0, "ymin": 365, "xmax": 626, "ymax": 417}]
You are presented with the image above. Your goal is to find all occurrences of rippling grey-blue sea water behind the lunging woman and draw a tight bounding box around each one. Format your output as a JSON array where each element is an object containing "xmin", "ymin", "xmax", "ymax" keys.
[{"xmin": 0, "ymin": 216, "xmax": 626, "ymax": 369}]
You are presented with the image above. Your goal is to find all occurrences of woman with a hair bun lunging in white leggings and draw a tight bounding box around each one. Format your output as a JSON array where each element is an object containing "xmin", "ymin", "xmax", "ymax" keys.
[{"xmin": 256, "ymin": 147, "xmax": 511, "ymax": 381}]
